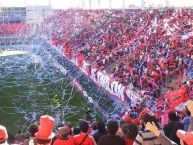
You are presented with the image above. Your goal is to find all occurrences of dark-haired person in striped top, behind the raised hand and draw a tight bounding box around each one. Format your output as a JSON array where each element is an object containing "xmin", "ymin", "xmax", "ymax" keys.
[{"xmin": 133, "ymin": 113, "xmax": 161, "ymax": 145}]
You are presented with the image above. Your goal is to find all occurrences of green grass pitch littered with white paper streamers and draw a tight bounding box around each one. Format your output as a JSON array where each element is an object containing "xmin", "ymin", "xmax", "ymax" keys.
[{"xmin": 0, "ymin": 48, "xmax": 92, "ymax": 133}]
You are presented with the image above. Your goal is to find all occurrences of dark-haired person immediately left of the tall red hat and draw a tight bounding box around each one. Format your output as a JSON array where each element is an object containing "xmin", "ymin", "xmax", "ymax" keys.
[{"xmin": 22, "ymin": 123, "xmax": 38, "ymax": 145}]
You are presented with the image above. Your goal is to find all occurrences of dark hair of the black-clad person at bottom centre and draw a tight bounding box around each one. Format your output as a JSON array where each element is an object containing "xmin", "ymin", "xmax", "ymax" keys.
[{"xmin": 107, "ymin": 120, "xmax": 119, "ymax": 135}]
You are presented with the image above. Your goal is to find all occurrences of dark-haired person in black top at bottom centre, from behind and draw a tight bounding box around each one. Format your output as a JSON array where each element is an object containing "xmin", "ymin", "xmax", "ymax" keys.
[{"xmin": 98, "ymin": 120, "xmax": 125, "ymax": 145}]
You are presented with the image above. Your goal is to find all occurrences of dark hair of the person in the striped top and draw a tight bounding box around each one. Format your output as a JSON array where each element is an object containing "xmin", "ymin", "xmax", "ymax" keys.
[{"xmin": 141, "ymin": 113, "xmax": 159, "ymax": 130}]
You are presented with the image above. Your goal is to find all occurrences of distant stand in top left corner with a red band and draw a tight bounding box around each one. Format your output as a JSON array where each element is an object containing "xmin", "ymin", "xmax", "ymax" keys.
[{"xmin": 0, "ymin": 7, "xmax": 30, "ymax": 45}]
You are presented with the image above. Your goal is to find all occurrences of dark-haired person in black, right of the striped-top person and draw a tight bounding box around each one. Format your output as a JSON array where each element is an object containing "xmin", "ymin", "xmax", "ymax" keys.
[{"xmin": 163, "ymin": 111, "xmax": 184, "ymax": 144}]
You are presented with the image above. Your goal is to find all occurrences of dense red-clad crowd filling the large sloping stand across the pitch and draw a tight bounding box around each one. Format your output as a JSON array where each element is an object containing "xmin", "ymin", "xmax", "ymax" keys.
[{"xmin": 44, "ymin": 9, "xmax": 193, "ymax": 110}]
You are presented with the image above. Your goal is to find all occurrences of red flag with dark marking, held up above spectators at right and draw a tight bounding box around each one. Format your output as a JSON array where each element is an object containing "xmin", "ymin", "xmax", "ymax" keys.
[{"xmin": 166, "ymin": 87, "xmax": 187, "ymax": 108}]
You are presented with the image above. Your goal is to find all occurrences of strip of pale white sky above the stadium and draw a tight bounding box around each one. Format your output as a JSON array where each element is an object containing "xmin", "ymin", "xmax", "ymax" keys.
[{"xmin": 0, "ymin": 0, "xmax": 193, "ymax": 9}]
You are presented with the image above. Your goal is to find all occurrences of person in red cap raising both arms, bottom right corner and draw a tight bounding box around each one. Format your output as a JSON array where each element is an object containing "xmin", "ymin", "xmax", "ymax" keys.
[{"xmin": 146, "ymin": 100, "xmax": 193, "ymax": 145}]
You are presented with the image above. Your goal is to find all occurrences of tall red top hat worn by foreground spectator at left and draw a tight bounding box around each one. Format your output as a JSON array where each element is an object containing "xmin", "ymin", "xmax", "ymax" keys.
[{"xmin": 35, "ymin": 115, "xmax": 55, "ymax": 140}]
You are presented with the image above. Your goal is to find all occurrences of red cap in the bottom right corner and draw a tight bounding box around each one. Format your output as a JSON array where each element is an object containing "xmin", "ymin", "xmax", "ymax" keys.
[{"xmin": 176, "ymin": 130, "xmax": 193, "ymax": 145}]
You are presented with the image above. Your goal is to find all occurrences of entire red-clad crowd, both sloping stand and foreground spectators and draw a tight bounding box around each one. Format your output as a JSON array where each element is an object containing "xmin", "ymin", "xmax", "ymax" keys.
[{"xmin": 0, "ymin": 9, "xmax": 193, "ymax": 145}]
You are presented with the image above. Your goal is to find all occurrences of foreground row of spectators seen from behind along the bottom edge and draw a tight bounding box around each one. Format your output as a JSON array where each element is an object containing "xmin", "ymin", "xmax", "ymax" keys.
[{"xmin": 0, "ymin": 100, "xmax": 193, "ymax": 145}]
